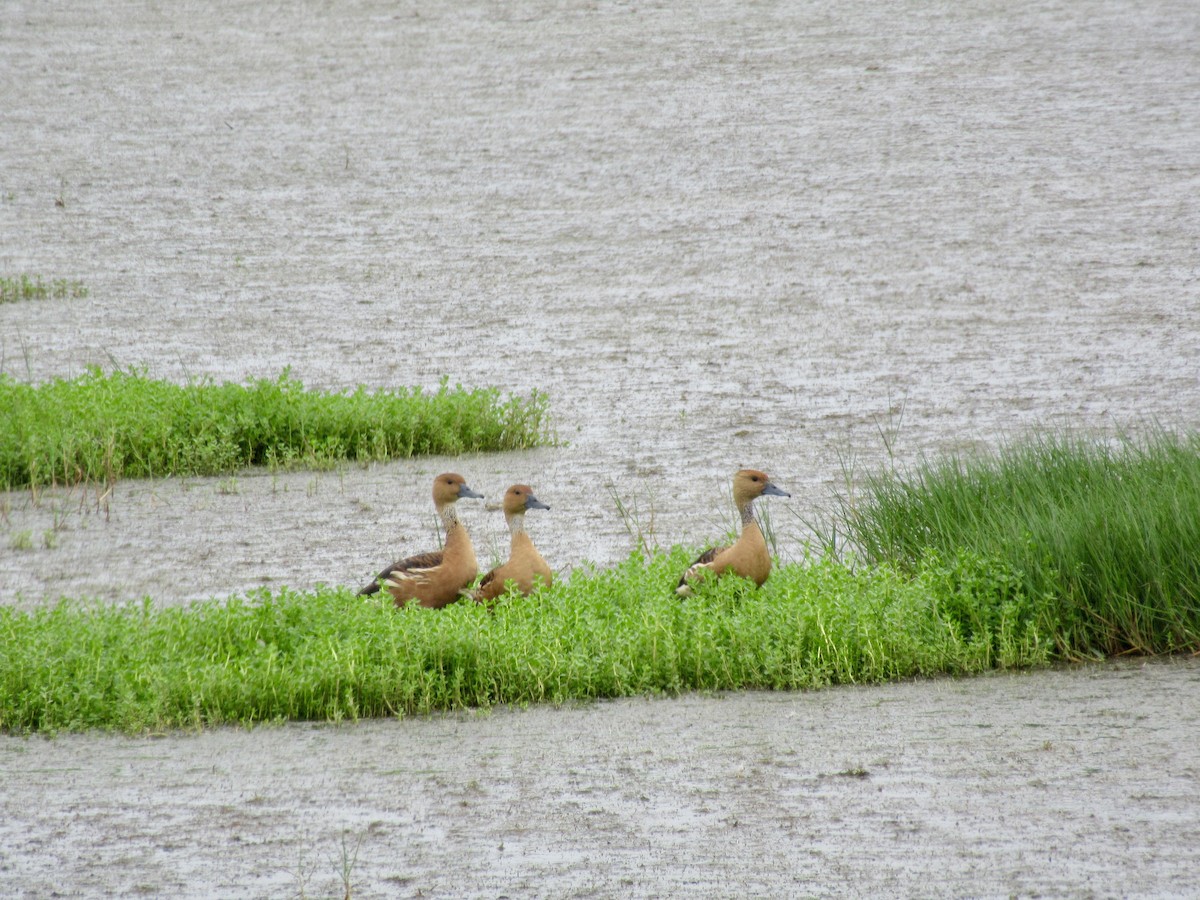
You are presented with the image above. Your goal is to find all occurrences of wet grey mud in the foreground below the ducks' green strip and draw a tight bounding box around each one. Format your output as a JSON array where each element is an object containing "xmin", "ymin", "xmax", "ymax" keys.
[{"xmin": 0, "ymin": 661, "xmax": 1200, "ymax": 898}]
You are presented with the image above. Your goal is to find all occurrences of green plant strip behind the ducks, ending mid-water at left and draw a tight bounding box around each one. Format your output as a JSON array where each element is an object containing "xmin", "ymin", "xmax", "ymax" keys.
[{"xmin": 0, "ymin": 368, "xmax": 547, "ymax": 490}]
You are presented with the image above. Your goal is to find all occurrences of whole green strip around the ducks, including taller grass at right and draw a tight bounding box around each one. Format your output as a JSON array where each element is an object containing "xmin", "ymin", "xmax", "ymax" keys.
[{"xmin": 0, "ymin": 432, "xmax": 1200, "ymax": 732}]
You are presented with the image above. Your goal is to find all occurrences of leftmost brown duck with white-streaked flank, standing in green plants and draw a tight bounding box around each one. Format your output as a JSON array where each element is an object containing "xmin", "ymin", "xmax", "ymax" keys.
[{"xmin": 359, "ymin": 472, "xmax": 484, "ymax": 610}]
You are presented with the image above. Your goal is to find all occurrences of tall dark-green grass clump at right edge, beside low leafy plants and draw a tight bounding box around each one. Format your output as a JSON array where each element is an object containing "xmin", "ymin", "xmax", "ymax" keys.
[{"xmin": 838, "ymin": 430, "xmax": 1200, "ymax": 656}]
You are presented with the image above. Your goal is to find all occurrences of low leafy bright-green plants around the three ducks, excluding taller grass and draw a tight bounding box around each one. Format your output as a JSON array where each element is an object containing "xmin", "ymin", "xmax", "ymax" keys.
[{"xmin": 0, "ymin": 548, "xmax": 1052, "ymax": 732}]
